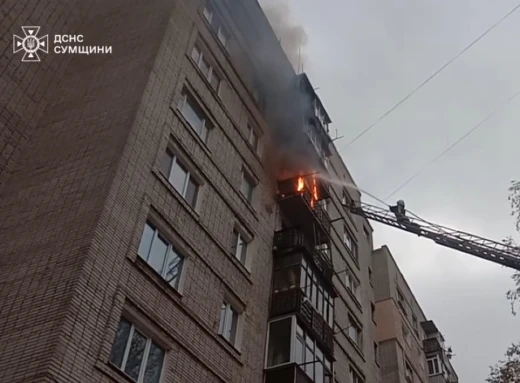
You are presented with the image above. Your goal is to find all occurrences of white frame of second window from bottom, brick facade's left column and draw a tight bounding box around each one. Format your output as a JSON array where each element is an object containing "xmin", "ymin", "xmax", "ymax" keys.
[{"xmin": 137, "ymin": 218, "xmax": 186, "ymax": 292}]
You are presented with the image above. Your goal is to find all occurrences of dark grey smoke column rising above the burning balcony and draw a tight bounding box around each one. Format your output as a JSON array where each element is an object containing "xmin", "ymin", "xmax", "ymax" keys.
[{"xmin": 255, "ymin": 0, "xmax": 318, "ymax": 179}]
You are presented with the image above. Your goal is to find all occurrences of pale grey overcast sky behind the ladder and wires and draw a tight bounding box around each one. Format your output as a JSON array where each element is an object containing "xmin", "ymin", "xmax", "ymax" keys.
[{"xmin": 262, "ymin": 0, "xmax": 520, "ymax": 383}]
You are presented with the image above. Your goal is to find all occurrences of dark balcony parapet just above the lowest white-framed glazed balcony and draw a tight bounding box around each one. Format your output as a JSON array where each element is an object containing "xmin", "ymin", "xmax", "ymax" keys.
[{"xmin": 270, "ymin": 288, "xmax": 334, "ymax": 356}]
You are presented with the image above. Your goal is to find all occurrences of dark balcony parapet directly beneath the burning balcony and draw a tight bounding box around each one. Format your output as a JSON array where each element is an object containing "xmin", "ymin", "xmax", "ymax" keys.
[{"xmin": 273, "ymin": 227, "xmax": 334, "ymax": 284}]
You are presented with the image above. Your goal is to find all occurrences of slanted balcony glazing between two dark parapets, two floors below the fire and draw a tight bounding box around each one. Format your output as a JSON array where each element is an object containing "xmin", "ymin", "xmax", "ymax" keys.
[{"xmin": 300, "ymin": 259, "xmax": 334, "ymax": 327}]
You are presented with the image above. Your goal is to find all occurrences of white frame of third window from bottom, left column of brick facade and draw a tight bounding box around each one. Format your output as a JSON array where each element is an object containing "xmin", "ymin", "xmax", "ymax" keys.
[{"xmin": 160, "ymin": 146, "xmax": 203, "ymax": 211}]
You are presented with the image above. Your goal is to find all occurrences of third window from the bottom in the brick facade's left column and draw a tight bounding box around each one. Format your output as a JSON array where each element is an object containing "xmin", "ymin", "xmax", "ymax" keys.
[{"xmin": 161, "ymin": 149, "xmax": 200, "ymax": 208}]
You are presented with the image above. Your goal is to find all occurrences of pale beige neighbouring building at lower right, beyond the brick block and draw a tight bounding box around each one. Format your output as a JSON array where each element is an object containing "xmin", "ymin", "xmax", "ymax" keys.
[{"xmin": 372, "ymin": 246, "xmax": 458, "ymax": 383}]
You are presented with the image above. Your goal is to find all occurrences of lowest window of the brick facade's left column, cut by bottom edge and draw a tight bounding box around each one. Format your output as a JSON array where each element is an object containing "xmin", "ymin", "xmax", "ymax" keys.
[{"xmin": 110, "ymin": 318, "xmax": 165, "ymax": 383}]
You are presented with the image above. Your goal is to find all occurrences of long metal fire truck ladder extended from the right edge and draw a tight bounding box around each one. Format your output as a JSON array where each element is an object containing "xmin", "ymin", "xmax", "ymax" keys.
[{"xmin": 345, "ymin": 203, "xmax": 520, "ymax": 270}]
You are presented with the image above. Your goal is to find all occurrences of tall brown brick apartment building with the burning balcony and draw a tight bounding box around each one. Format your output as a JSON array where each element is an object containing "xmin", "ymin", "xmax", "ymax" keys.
[{"xmin": 0, "ymin": 0, "xmax": 381, "ymax": 383}]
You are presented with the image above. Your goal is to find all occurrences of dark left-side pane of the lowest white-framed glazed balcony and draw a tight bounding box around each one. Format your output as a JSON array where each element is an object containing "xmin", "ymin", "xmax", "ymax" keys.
[{"xmin": 267, "ymin": 318, "xmax": 292, "ymax": 367}]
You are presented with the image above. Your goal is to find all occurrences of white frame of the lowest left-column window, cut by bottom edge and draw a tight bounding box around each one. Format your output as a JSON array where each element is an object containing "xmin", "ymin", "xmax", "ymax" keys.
[{"xmin": 108, "ymin": 315, "xmax": 168, "ymax": 383}]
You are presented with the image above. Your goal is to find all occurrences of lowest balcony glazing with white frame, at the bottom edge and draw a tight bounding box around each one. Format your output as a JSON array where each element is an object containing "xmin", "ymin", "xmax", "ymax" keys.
[{"xmin": 267, "ymin": 316, "xmax": 332, "ymax": 383}]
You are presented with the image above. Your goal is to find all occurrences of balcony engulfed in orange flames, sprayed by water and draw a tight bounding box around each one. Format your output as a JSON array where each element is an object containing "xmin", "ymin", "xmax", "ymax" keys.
[{"xmin": 278, "ymin": 174, "xmax": 331, "ymax": 236}]
